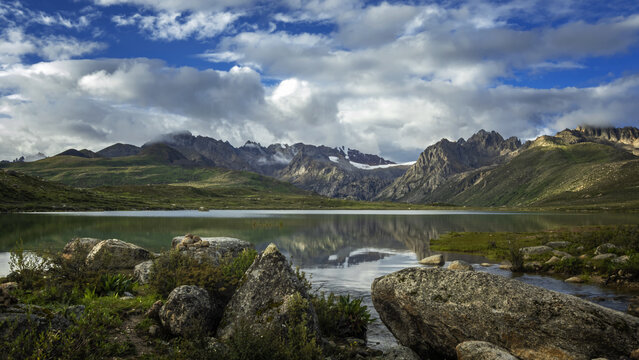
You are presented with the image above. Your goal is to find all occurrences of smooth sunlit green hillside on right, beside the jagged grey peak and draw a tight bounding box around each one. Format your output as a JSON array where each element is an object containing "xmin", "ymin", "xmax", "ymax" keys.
[{"xmin": 429, "ymin": 143, "xmax": 639, "ymax": 209}]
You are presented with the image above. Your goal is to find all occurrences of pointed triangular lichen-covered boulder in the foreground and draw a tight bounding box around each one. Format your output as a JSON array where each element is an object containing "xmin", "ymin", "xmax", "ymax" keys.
[{"xmin": 217, "ymin": 244, "xmax": 319, "ymax": 339}]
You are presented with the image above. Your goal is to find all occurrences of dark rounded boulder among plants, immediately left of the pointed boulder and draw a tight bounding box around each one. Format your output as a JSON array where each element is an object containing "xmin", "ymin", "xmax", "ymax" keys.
[{"xmin": 159, "ymin": 285, "xmax": 213, "ymax": 337}]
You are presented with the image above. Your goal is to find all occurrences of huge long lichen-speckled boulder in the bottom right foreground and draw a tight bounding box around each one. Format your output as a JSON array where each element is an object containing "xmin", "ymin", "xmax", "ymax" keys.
[{"xmin": 372, "ymin": 268, "xmax": 639, "ymax": 359}]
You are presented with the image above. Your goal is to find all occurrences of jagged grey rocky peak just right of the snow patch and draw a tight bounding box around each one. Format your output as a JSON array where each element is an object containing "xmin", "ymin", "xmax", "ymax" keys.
[{"xmin": 376, "ymin": 130, "xmax": 522, "ymax": 202}]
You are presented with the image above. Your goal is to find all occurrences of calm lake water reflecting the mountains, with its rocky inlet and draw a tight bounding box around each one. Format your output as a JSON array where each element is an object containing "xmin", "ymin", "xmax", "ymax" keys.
[{"xmin": 0, "ymin": 210, "xmax": 639, "ymax": 348}]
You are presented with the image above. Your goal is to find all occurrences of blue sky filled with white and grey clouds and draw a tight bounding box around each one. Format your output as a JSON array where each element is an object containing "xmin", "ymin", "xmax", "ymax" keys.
[{"xmin": 0, "ymin": 0, "xmax": 639, "ymax": 161}]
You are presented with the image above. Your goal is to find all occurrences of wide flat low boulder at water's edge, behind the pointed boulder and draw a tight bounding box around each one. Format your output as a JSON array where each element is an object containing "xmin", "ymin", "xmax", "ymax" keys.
[{"xmin": 171, "ymin": 234, "xmax": 253, "ymax": 264}]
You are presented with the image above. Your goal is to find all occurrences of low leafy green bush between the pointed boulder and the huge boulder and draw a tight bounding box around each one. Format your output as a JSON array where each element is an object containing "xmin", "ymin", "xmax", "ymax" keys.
[{"xmin": 312, "ymin": 293, "xmax": 374, "ymax": 339}]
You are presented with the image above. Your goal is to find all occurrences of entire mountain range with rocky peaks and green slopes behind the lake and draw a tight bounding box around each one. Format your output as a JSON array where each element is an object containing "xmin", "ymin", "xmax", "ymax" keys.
[{"xmin": 3, "ymin": 126, "xmax": 639, "ymax": 208}]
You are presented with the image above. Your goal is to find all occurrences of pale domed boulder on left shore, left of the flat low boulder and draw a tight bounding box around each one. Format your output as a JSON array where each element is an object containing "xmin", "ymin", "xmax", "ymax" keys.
[{"xmin": 86, "ymin": 239, "xmax": 153, "ymax": 269}]
